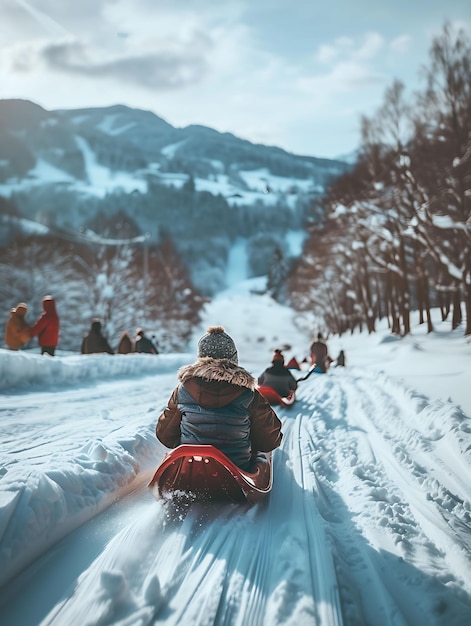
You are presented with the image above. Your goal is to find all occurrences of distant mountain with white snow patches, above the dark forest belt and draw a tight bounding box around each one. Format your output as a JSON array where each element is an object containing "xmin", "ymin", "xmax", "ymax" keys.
[{"xmin": 0, "ymin": 100, "xmax": 347, "ymax": 203}]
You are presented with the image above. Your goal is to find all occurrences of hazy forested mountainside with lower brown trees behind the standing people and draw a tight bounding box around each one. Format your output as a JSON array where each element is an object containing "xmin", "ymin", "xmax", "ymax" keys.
[{"xmin": 0, "ymin": 100, "xmax": 348, "ymax": 350}]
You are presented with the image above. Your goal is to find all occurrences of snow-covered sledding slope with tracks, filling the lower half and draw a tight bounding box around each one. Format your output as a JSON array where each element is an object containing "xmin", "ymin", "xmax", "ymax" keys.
[{"xmin": 0, "ymin": 282, "xmax": 471, "ymax": 626}]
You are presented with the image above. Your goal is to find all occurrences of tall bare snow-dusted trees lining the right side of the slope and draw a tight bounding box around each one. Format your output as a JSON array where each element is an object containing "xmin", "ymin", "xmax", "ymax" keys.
[{"xmin": 290, "ymin": 24, "xmax": 471, "ymax": 335}]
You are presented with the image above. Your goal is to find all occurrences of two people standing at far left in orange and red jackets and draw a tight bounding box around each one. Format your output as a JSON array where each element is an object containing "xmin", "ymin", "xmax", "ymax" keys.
[{"xmin": 5, "ymin": 296, "xmax": 60, "ymax": 356}]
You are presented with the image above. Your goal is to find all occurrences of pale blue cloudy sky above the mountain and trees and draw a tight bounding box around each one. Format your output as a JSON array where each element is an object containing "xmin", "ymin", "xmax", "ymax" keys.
[{"xmin": 0, "ymin": 0, "xmax": 471, "ymax": 157}]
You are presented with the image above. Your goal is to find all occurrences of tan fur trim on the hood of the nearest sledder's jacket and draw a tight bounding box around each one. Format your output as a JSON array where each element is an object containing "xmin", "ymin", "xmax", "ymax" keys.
[{"xmin": 178, "ymin": 357, "xmax": 257, "ymax": 391}]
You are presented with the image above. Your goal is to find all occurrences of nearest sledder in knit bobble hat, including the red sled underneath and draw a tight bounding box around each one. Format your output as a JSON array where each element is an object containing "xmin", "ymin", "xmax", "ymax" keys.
[{"xmin": 149, "ymin": 326, "xmax": 282, "ymax": 502}]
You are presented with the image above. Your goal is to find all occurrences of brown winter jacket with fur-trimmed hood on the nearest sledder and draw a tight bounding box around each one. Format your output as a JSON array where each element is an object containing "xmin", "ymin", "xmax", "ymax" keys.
[{"xmin": 156, "ymin": 357, "xmax": 283, "ymax": 464}]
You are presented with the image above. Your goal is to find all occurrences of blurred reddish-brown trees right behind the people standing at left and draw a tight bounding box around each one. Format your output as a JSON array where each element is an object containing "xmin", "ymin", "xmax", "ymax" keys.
[{"xmin": 0, "ymin": 235, "xmax": 205, "ymax": 352}]
